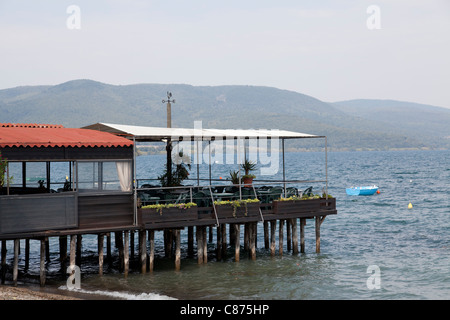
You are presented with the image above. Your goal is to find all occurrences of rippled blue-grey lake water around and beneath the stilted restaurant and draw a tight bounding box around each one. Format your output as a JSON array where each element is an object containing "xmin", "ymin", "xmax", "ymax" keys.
[{"xmin": 4, "ymin": 151, "xmax": 450, "ymax": 300}]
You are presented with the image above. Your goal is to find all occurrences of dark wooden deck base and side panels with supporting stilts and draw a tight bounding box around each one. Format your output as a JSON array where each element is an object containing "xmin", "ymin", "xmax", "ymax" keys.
[{"xmin": 0, "ymin": 192, "xmax": 337, "ymax": 285}]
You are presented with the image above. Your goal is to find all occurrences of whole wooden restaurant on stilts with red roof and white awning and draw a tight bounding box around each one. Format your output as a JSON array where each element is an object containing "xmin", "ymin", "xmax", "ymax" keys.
[{"xmin": 0, "ymin": 123, "xmax": 337, "ymax": 286}]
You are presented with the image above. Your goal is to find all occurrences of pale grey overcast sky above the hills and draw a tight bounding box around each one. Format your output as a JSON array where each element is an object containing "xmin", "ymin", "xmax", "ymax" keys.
[{"xmin": 0, "ymin": 0, "xmax": 450, "ymax": 107}]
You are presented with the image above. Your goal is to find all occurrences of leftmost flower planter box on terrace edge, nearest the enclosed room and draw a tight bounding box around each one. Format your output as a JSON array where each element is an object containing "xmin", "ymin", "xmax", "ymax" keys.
[{"xmin": 138, "ymin": 207, "xmax": 198, "ymax": 227}]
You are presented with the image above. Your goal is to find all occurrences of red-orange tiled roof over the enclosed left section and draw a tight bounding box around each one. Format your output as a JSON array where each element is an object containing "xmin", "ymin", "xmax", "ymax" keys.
[{"xmin": 0, "ymin": 124, "xmax": 133, "ymax": 148}]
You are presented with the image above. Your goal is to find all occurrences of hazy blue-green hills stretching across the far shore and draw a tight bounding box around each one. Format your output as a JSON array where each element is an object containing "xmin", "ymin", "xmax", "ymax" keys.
[{"xmin": 0, "ymin": 80, "xmax": 450, "ymax": 150}]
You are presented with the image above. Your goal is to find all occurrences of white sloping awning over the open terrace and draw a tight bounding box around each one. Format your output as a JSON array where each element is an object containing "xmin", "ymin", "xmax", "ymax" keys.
[{"xmin": 83, "ymin": 123, "xmax": 324, "ymax": 142}]
